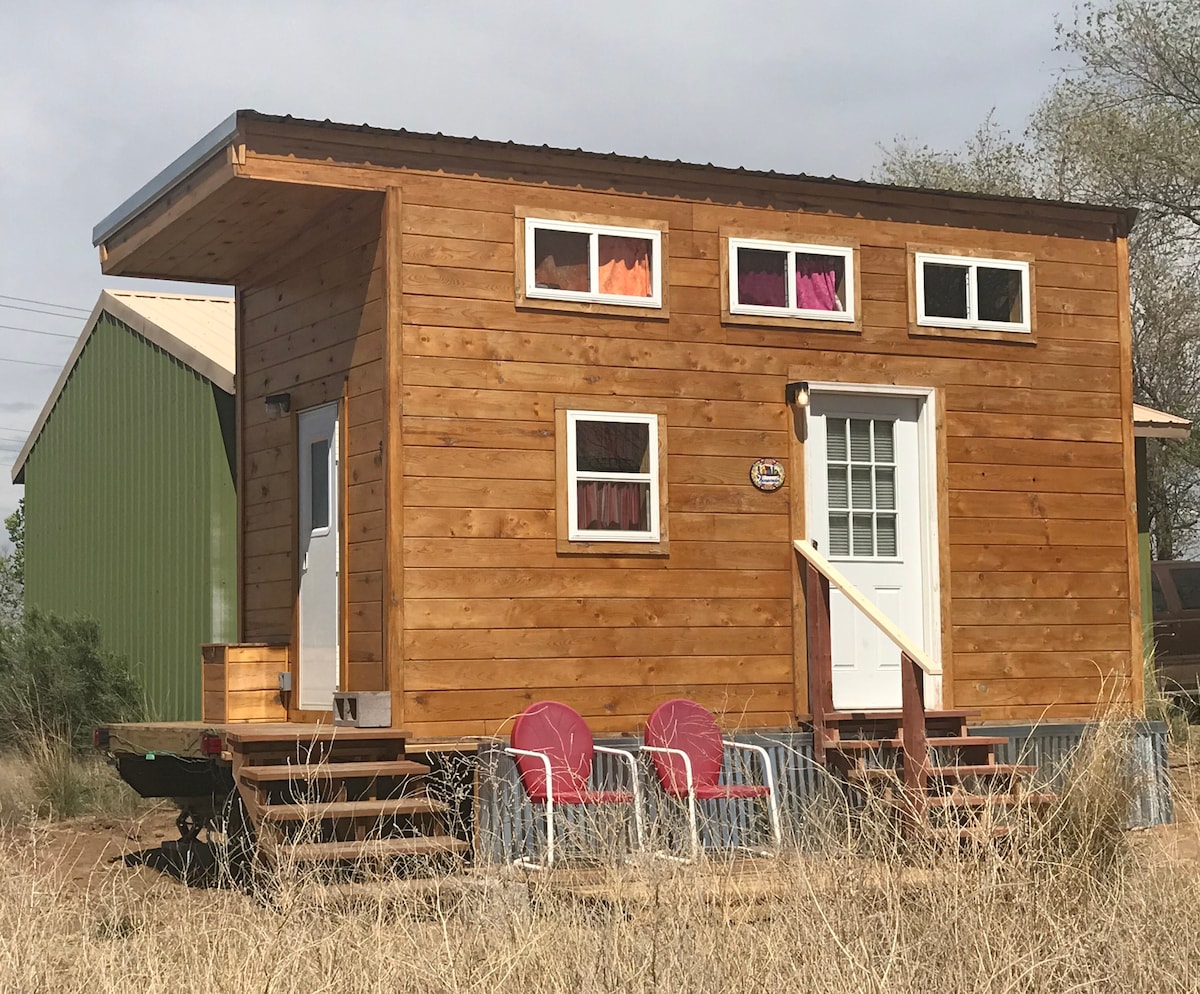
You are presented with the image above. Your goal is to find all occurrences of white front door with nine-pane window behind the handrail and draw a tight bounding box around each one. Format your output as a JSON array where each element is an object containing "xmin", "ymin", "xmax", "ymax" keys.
[{"xmin": 804, "ymin": 389, "xmax": 936, "ymax": 711}]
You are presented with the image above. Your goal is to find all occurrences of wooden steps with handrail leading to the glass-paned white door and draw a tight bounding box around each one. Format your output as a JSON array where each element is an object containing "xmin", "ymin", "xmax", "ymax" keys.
[{"xmin": 796, "ymin": 541, "xmax": 1056, "ymax": 839}]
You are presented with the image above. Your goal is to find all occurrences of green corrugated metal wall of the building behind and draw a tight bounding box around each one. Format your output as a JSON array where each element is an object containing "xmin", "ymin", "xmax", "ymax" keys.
[{"xmin": 25, "ymin": 313, "xmax": 238, "ymax": 720}]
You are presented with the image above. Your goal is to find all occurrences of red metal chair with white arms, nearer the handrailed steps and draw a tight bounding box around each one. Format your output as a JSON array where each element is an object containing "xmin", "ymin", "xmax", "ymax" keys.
[{"xmin": 644, "ymin": 699, "xmax": 782, "ymax": 860}]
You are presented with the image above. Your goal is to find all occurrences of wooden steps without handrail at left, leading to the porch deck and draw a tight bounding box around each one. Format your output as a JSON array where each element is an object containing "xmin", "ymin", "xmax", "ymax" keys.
[{"xmin": 223, "ymin": 724, "xmax": 469, "ymax": 867}]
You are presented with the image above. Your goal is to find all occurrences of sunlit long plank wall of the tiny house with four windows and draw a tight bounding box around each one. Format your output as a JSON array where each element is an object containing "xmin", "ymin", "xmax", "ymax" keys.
[{"xmin": 393, "ymin": 173, "xmax": 1133, "ymax": 733}]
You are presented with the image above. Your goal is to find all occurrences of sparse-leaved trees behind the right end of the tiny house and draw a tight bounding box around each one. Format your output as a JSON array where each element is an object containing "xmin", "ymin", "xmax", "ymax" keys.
[{"xmin": 875, "ymin": 0, "xmax": 1200, "ymax": 558}]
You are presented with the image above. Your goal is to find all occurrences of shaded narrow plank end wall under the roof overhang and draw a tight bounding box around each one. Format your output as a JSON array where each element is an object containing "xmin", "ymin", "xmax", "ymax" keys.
[{"xmin": 238, "ymin": 193, "xmax": 385, "ymax": 690}]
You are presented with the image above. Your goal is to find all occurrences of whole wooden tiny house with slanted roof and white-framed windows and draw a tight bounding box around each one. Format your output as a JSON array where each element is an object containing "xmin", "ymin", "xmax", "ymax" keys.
[{"xmin": 95, "ymin": 110, "xmax": 1142, "ymax": 738}]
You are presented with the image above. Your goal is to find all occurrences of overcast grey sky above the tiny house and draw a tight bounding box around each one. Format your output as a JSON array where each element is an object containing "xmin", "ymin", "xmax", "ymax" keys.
[{"xmin": 0, "ymin": 0, "xmax": 1069, "ymax": 537}]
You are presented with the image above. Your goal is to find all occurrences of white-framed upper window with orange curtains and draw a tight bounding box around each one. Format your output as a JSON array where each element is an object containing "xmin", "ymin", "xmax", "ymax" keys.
[{"xmin": 524, "ymin": 217, "xmax": 662, "ymax": 307}]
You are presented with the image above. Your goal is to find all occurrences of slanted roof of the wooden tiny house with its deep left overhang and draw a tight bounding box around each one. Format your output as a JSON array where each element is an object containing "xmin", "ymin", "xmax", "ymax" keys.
[{"xmin": 92, "ymin": 110, "xmax": 1135, "ymax": 283}]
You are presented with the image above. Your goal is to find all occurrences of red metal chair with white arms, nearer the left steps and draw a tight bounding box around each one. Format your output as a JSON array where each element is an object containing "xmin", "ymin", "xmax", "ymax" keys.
[{"xmin": 504, "ymin": 701, "xmax": 644, "ymax": 869}]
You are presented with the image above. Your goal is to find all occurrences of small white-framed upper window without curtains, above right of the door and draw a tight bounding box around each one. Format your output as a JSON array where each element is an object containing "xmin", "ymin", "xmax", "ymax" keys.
[{"xmin": 913, "ymin": 252, "xmax": 1032, "ymax": 333}]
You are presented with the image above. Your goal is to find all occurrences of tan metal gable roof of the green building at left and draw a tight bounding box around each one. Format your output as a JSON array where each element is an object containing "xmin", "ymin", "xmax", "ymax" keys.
[{"xmin": 12, "ymin": 291, "xmax": 235, "ymax": 483}]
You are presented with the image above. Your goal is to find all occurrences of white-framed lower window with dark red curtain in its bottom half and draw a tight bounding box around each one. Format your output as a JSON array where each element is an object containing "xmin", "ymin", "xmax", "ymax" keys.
[{"xmin": 566, "ymin": 411, "xmax": 661, "ymax": 543}]
